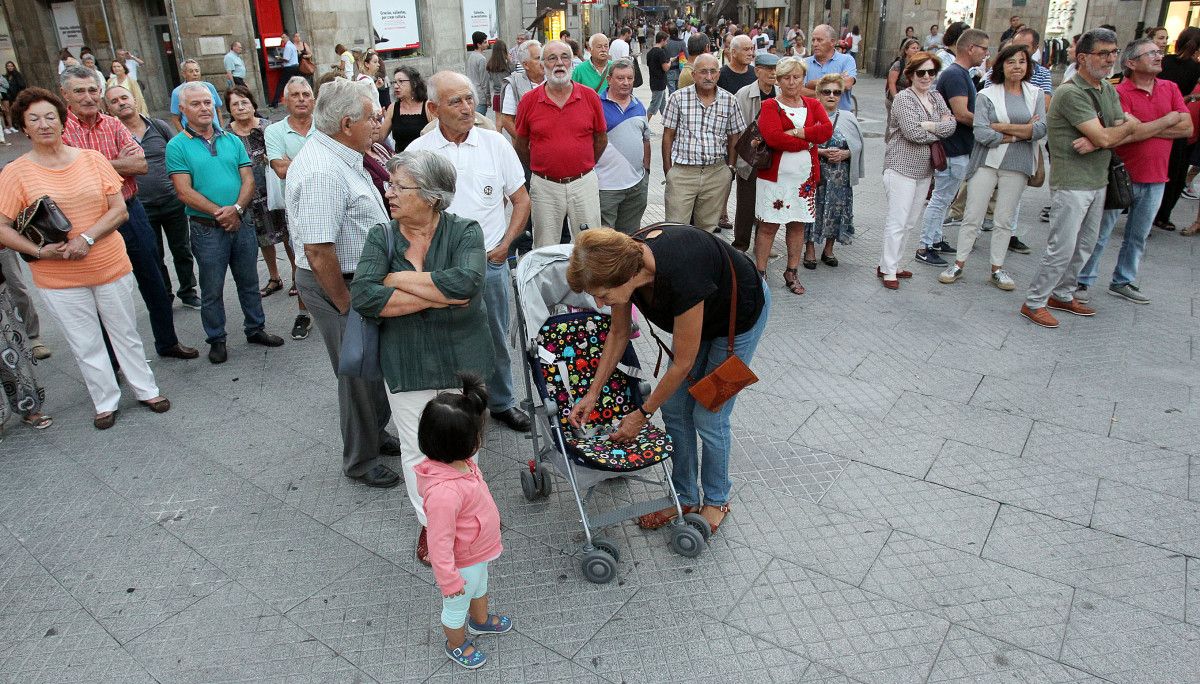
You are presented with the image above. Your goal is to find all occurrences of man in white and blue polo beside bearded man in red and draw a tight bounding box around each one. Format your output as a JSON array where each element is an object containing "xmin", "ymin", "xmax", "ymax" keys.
[{"xmin": 596, "ymin": 58, "xmax": 650, "ymax": 234}]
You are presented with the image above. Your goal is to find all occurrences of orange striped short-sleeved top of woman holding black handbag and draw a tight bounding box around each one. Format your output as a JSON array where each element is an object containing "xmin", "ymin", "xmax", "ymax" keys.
[{"xmin": 0, "ymin": 150, "xmax": 133, "ymax": 289}]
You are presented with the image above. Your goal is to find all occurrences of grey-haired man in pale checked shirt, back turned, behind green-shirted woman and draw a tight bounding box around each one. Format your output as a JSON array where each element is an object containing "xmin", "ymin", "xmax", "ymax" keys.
[{"xmin": 276, "ymin": 79, "xmax": 401, "ymax": 487}]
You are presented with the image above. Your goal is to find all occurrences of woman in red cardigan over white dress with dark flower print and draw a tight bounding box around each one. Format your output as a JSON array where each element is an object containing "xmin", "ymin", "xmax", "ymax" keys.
[{"xmin": 754, "ymin": 58, "xmax": 833, "ymax": 294}]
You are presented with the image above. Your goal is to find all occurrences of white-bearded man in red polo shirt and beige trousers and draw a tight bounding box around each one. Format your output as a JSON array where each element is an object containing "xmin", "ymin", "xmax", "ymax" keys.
[{"xmin": 512, "ymin": 41, "xmax": 608, "ymax": 247}]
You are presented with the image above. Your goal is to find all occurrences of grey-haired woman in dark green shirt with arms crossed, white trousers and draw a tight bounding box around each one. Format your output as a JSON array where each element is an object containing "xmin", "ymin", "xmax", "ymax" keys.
[{"xmin": 350, "ymin": 148, "xmax": 492, "ymax": 565}]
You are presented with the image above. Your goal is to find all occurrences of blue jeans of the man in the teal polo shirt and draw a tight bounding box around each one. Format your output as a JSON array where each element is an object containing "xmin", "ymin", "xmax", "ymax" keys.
[{"xmin": 188, "ymin": 216, "xmax": 266, "ymax": 344}]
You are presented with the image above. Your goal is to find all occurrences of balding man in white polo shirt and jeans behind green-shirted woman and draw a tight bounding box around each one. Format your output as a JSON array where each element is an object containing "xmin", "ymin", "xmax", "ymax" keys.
[{"xmin": 408, "ymin": 71, "xmax": 530, "ymax": 432}]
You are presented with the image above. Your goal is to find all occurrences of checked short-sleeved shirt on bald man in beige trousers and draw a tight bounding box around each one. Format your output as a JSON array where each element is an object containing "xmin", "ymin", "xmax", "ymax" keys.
[{"xmin": 662, "ymin": 85, "xmax": 746, "ymax": 166}]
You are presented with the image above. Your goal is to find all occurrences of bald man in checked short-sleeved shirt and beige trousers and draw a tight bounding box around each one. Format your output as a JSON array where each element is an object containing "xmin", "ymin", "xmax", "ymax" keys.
[{"xmin": 662, "ymin": 54, "xmax": 746, "ymax": 233}]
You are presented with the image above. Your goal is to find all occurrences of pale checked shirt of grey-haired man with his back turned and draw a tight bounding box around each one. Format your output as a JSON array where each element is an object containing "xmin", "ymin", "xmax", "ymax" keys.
[{"xmin": 286, "ymin": 131, "xmax": 390, "ymax": 274}]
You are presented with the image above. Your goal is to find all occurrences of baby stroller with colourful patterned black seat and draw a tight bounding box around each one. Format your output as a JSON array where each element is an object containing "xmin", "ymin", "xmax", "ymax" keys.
[{"xmin": 509, "ymin": 245, "xmax": 712, "ymax": 584}]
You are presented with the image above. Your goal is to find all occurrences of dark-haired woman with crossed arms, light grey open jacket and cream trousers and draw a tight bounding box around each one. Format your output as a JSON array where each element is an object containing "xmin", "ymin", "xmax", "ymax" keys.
[{"xmin": 937, "ymin": 44, "xmax": 1046, "ymax": 290}]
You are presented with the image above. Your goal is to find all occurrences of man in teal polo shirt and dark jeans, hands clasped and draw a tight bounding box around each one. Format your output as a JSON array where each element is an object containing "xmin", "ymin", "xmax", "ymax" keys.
[{"xmin": 167, "ymin": 83, "xmax": 283, "ymax": 364}]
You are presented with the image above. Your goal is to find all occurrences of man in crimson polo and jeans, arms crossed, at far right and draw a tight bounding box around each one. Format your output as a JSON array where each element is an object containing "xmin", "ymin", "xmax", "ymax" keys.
[{"xmin": 1075, "ymin": 40, "xmax": 1192, "ymax": 304}]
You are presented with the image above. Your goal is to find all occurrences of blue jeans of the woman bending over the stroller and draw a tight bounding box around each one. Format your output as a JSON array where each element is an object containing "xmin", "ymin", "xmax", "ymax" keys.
[{"xmin": 662, "ymin": 278, "xmax": 770, "ymax": 506}]
